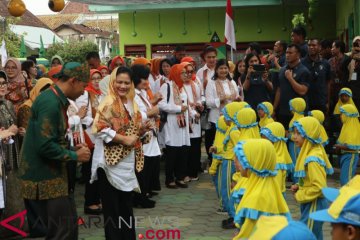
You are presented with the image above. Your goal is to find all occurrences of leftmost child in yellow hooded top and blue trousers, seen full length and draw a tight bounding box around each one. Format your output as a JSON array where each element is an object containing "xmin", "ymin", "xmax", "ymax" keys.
[{"xmin": 210, "ymin": 102, "xmax": 250, "ymax": 228}]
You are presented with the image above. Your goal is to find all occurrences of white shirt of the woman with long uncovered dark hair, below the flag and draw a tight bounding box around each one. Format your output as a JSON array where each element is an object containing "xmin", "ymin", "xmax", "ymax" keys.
[{"xmin": 205, "ymin": 80, "xmax": 239, "ymax": 123}]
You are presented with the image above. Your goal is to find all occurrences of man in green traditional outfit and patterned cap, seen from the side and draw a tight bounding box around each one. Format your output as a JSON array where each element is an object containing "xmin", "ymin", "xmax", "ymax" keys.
[{"xmin": 20, "ymin": 62, "xmax": 90, "ymax": 240}]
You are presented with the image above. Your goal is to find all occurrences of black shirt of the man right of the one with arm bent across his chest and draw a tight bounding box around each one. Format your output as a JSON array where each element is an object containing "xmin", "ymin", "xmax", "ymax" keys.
[{"xmin": 301, "ymin": 55, "xmax": 331, "ymax": 110}]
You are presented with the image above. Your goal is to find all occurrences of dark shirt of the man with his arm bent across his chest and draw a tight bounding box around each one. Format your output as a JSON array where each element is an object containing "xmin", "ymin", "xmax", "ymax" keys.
[{"xmin": 279, "ymin": 62, "xmax": 310, "ymax": 115}]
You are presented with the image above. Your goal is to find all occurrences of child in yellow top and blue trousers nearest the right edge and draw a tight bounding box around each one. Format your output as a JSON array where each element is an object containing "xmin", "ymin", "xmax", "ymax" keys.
[{"xmin": 335, "ymin": 104, "xmax": 360, "ymax": 186}]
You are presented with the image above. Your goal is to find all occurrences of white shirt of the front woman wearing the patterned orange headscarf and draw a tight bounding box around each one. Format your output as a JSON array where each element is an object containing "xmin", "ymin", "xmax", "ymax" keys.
[{"xmin": 90, "ymin": 103, "xmax": 140, "ymax": 192}]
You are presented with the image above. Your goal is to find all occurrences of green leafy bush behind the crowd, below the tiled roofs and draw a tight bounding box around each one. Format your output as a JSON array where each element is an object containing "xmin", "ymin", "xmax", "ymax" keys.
[{"xmin": 45, "ymin": 41, "xmax": 99, "ymax": 63}]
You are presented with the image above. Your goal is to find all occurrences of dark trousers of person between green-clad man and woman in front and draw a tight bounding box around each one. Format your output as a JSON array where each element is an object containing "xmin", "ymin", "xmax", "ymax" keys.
[{"xmin": 81, "ymin": 151, "xmax": 100, "ymax": 207}]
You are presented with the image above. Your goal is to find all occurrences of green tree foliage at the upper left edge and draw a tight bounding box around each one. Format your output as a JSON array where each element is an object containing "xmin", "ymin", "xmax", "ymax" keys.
[{"xmin": 0, "ymin": 17, "xmax": 21, "ymax": 57}]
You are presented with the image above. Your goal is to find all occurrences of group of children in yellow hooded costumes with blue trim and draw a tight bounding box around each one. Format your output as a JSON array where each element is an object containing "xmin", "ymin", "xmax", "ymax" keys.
[{"xmin": 209, "ymin": 88, "xmax": 360, "ymax": 239}]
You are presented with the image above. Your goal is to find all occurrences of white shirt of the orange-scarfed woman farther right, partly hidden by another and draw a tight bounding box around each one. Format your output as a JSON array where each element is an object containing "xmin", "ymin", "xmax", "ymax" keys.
[{"xmin": 184, "ymin": 83, "xmax": 201, "ymax": 138}]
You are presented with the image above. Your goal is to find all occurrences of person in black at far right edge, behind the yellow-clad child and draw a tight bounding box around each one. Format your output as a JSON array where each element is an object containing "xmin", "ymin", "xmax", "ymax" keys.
[{"xmin": 344, "ymin": 36, "xmax": 360, "ymax": 109}]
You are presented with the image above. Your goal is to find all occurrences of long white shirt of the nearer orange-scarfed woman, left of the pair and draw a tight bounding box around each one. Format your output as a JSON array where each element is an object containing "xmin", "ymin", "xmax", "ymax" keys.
[{"xmin": 158, "ymin": 81, "xmax": 190, "ymax": 147}]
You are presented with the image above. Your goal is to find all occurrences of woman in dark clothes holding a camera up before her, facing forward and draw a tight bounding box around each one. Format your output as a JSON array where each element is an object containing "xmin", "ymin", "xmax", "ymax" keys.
[{"xmin": 243, "ymin": 53, "xmax": 273, "ymax": 109}]
